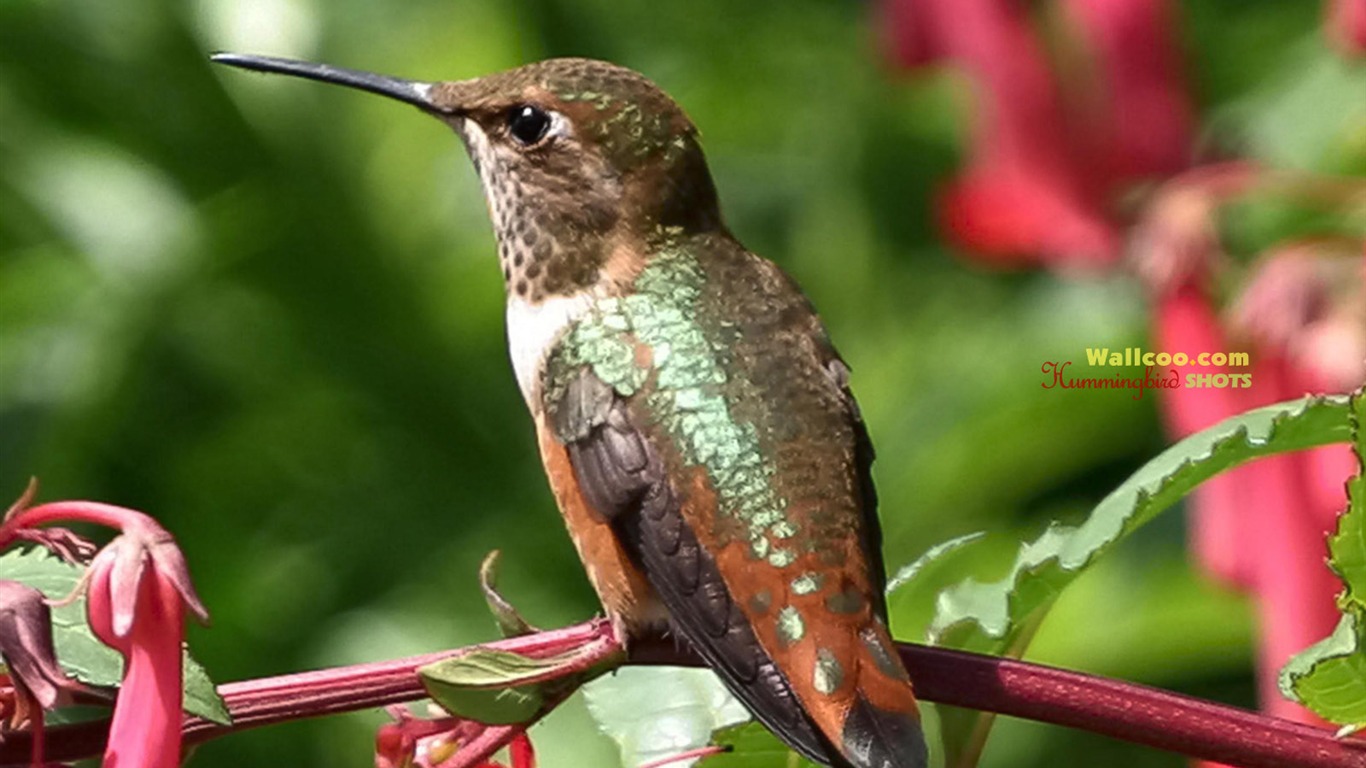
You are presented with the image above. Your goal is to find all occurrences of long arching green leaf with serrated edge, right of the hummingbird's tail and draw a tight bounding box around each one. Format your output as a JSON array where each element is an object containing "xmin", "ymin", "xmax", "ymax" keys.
[{"xmin": 930, "ymin": 396, "xmax": 1351, "ymax": 767}]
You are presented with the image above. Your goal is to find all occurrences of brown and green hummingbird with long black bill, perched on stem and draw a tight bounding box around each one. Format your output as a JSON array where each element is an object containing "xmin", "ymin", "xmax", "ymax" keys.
[{"xmin": 213, "ymin": 53, "xmax": 928, "ymax": 768}]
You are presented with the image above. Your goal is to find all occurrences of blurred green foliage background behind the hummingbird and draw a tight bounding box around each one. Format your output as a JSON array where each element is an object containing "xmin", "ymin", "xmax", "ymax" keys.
[{"xmin": 0, "ymin": 0, "xmax": 1333, "ymax": 768}]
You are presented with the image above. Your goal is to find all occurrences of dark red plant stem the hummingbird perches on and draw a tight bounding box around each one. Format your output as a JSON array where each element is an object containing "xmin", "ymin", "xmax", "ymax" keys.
[{"xmin": 10, "ymin": 622, "xmax": 1366, "ymax": 768}]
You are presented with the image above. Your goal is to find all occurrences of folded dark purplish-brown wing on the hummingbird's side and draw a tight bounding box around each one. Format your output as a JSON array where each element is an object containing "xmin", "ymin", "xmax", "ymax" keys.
[{"xmin": 555, "ymin": 369, "xmax": 844, "ymax": 765}]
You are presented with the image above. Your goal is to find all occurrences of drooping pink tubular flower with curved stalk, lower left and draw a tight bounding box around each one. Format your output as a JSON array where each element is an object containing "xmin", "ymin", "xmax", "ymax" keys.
[{"xmin": 0, "ymin": 502, "xmax": 208, "ymax": 768}]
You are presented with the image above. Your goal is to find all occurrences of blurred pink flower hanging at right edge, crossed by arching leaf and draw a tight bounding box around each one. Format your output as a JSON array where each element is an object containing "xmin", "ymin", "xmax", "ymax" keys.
[{"xmin": 1229, "ymin": 241, "xmax": 1366, "ymax": 719}]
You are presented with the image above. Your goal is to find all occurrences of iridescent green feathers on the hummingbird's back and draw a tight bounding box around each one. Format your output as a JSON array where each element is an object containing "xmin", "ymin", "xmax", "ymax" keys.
[{"xmin": 544, "ymin": 243, "xmax": 859, "ymax": 567}]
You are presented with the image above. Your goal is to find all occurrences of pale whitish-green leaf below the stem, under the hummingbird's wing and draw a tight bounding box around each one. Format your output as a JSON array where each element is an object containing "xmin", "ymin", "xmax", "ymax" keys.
[{"xmin": 583, "ymin": 667, "xmax": 754, "ymax": 765}]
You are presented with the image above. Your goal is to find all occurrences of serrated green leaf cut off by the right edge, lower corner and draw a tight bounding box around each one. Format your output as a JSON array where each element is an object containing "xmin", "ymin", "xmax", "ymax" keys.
[{"xmin": 1280, "ymin": 391, "xmax": 1366, "ymax": 726}]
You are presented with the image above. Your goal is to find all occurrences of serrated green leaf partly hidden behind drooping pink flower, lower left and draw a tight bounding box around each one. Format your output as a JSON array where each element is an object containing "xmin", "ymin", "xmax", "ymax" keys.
[{"xmin": 0, "ymin": 547, "xmax": 232, "ymax": 726}]
